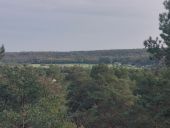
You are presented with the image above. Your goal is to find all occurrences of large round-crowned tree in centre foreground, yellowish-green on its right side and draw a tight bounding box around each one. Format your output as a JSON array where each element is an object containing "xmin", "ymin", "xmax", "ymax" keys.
[{"xmin": 68, "ymin": 65, "xmax": 136, "ymax": 128}]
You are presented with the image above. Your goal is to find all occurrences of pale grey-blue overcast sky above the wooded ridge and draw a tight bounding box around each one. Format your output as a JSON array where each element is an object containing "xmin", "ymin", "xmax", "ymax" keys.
[{"xmin": 0, "ymin": 0, "xmax": 164, "ymax": 52}]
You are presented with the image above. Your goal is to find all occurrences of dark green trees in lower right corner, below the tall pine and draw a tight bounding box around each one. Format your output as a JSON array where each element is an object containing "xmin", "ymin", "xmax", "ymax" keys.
[{"xmin": 129, "ymin": 69, "xmax": 170, "ymax": 128}]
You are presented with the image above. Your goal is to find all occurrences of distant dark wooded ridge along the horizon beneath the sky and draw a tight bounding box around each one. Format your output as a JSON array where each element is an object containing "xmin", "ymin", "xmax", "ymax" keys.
[{"xmin": 0, "ymin": 49, "xmax": 153, "ymax": 66}]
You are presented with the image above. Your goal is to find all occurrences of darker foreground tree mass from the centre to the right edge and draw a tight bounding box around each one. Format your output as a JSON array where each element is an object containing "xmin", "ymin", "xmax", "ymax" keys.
[{"xmin": 66, "ymin": 65, "xmax": 170, "ymax": 128}]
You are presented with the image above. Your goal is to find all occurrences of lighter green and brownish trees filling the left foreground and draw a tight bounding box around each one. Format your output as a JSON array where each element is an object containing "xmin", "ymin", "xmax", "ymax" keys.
[{"xmin": 0, "ymin": 66, "xmax": 75, "ymax": 128}]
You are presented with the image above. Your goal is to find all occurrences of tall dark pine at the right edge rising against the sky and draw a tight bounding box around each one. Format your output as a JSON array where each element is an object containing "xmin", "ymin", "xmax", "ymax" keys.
[{"xmin": 144, "ymin": 0, "xmax": 170, "ymax": 67}]
